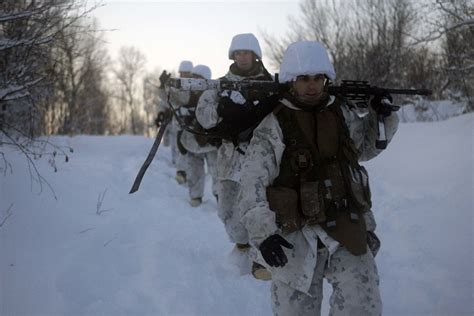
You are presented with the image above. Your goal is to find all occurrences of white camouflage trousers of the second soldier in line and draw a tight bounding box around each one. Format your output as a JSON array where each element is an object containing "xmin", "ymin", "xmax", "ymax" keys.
[{"xmin": 217, "ymin": 180, "xmax": 249, "ymax": 244}]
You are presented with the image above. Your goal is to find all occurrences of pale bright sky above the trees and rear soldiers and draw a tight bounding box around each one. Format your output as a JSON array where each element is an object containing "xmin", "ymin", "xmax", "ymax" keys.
[{"xmin": 92, "ymin": 0, "xmax": 299, "ymax": 78}]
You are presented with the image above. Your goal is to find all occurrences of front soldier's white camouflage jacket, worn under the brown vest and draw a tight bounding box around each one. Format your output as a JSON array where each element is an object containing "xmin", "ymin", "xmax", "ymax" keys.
[{"xmin": 240, "ymin": 97, "xmax": 398, "ymax": 293}]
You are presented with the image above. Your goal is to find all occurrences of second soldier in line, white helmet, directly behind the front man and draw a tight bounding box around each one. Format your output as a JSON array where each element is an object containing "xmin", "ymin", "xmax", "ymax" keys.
[{"xmin": 196, "ymin": 33, "xmax": 273, "ymax": 279}]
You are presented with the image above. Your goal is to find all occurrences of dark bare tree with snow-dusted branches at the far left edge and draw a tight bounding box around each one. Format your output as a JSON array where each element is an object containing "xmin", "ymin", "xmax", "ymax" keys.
[{"xmin": 0, "ymin": 0, "xmax": 101, "ymax": 194}]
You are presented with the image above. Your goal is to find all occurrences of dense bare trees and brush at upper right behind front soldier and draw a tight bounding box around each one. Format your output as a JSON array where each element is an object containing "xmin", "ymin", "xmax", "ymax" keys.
[{"xmin": 263, "ymin": 0, "xmax": 474, "ymax": 116}]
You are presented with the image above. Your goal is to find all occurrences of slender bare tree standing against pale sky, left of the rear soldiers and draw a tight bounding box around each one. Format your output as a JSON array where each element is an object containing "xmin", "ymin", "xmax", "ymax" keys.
[{"xmin": 114, "ymin": 46, "xmax": 146, "ymax": 134}]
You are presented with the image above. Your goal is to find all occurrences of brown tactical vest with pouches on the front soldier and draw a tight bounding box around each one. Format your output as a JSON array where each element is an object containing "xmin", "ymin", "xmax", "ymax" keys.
[{"xmin": 267, "ymin": 99, "xmax": 371, "ymax": 255}]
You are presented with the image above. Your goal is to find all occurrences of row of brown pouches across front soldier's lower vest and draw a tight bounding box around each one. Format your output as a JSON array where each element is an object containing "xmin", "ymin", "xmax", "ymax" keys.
[{"xmin": 266, "ymin": 161, "xmax": 371, "ymax": 233}]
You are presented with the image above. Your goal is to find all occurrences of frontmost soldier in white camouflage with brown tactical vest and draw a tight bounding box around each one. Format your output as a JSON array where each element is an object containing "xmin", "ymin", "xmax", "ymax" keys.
[{"xmin": 240, "ymin": 41, "xmax": 398, "ymax": 316}]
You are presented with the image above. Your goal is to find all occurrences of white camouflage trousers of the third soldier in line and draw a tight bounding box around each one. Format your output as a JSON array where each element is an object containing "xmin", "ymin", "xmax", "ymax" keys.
[{"xmin": 186, "ymin": 151, "xmax": 218, "ymax": 199}]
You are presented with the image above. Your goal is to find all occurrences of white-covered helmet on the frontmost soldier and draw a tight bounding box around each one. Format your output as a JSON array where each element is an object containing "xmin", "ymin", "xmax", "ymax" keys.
[{"xmin": 279, "ymin": 41, "xmax": 336, "ymax": 83}]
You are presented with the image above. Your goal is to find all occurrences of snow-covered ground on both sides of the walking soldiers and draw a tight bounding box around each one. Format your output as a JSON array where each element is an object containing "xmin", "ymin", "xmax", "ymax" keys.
[{"xmin": 0, "ymin": 114, "xmax": 474, "ymax": 316}]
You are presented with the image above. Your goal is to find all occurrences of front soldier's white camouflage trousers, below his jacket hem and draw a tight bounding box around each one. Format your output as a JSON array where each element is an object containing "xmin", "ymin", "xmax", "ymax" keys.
[{"xmin": 271, "ymin": 247, "xmax": 382, "ymax": 316}]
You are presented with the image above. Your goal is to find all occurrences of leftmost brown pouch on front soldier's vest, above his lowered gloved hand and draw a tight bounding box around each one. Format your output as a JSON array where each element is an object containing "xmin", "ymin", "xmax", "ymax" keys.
[{"xmin": 267, "ymin": 187, "xmax": 302, "ymax": 234}]
